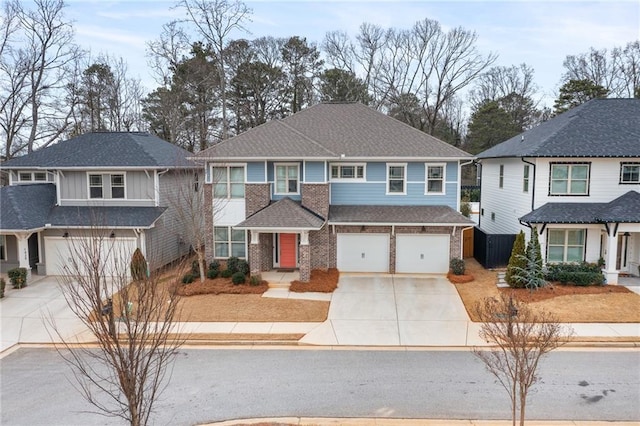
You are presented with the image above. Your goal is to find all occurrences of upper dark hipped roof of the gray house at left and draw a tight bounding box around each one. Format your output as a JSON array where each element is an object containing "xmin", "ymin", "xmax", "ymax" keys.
[{"xmin": 0, "ymin": 132, "xmax": 193, "ymax": 169}]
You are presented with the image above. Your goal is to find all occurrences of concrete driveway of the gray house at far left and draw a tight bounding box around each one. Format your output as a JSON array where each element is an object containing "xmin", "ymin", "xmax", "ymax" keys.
[{"xmin": 0, "ymin": 276, "xmax": 89, "ymax": 352}]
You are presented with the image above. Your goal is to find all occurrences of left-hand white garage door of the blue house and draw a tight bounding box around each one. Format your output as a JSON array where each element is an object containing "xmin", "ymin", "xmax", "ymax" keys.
[{"xmin": 337, "ymin": 234, "xmax": 389, "ymax": 272}]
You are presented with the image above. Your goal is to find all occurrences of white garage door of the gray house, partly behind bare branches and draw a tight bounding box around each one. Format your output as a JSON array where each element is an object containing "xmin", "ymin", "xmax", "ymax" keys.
[{"xmin": 44, "ymin": 237, "xmax": 136, "ymax": 275}]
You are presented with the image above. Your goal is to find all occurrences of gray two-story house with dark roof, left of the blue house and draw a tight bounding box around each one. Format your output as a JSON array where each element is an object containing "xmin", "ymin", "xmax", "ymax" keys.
[{"xmin": 0, "ymin": 132, "xmax": 195, "ymax": 275}]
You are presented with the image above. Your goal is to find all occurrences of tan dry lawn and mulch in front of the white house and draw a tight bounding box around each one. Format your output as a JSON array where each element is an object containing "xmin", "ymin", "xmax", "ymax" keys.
[{"xmin": 455, "ymin": 259, "xmax": 640, "ymax": 323}]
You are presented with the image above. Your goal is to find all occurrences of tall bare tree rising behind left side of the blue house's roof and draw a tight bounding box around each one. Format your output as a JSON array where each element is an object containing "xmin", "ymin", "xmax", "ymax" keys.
[{"xmin": 176, "ymin": 0, "xmax": 251, "ymax": 140}]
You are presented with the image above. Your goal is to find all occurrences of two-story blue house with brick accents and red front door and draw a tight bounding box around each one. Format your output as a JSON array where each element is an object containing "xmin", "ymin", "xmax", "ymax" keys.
[{"xmin": 192, "ymin": 103, "xmax": 473, "ymax": 281}]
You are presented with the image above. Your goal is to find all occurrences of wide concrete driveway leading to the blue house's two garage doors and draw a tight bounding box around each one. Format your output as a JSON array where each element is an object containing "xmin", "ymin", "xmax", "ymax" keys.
[{"xmin": 301, "ymin": 273, "xmax": 483, "ymax": 346}]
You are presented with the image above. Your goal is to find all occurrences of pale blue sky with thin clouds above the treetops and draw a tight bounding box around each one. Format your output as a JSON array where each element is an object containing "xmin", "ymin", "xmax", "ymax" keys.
[{"xmin": 65, "ymin": 0, "xmax": 640, "ymax": 105}]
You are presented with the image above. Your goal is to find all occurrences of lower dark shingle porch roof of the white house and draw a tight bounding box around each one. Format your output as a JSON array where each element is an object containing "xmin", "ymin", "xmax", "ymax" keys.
[{"xmin": 520, "ymin": 191, "xmax": 640, "ymax": 223}]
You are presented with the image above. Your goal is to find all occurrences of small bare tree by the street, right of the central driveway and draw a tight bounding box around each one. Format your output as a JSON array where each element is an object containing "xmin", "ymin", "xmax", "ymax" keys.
[{"xmin": 474, "ymin": 293, "xmax": 573, "ymax": 426}]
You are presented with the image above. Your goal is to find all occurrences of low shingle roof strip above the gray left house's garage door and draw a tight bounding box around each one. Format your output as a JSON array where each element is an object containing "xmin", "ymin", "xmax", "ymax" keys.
[{"xmin": 47, "ymin": 206, "xmax": 166, "ymax": 228}]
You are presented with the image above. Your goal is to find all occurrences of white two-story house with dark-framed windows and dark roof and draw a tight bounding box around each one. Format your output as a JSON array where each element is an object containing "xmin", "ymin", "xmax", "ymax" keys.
[{"xmin": 478, "ymin": 99, "xmax": 640, "ymax": 284}]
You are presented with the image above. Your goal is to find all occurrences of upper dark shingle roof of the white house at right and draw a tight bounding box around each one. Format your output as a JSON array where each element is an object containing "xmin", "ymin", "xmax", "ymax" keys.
[{"xmin": 477, "ymin": 99, "xmax": 640, "ymax": 159}]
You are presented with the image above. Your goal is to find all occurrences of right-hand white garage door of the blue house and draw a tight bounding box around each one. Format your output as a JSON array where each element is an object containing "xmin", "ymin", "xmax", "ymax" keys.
[{"xmin": 396, "ymin": 234, "xmax": 449, "ymax": 274}]
